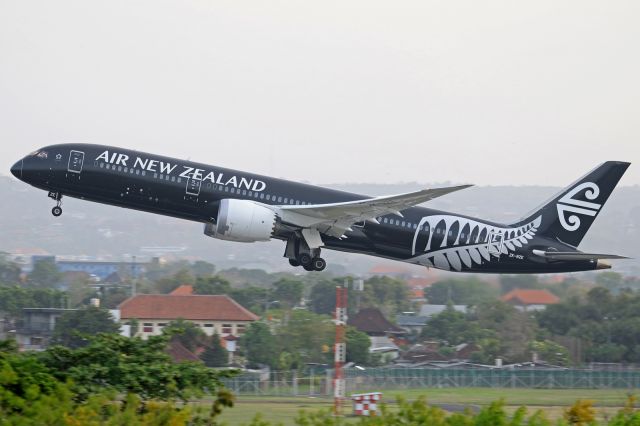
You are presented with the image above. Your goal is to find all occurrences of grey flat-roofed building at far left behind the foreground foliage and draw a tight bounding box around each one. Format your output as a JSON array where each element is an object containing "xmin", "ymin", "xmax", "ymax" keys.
[{"xmin": 15, "ymin": 308, "xmax": 76, "ymax": 351}]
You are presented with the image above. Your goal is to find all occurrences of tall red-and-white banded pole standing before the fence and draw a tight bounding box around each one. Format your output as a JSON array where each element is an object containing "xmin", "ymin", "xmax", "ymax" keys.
[{"xmin": 333, "ymin": 279, "xmax": 348, "ymax": 416}]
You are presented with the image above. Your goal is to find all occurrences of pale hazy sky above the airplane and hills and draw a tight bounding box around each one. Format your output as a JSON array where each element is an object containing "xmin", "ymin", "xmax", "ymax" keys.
[{"xmin": 0, "ymin": 0, "xmax": 640, "ymax": 186}]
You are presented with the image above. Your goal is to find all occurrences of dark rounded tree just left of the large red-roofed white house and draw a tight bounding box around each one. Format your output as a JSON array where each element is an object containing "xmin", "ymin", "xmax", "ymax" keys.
[{"xmin": 52, "ymin": 306, "xmax": 120, "ymax": 348}]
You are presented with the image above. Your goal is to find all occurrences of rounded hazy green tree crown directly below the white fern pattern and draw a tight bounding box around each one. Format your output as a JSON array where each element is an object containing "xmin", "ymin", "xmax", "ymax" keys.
[{"xmin": 424, "ymin": 277, "xmax": 498, "ymax": 305}]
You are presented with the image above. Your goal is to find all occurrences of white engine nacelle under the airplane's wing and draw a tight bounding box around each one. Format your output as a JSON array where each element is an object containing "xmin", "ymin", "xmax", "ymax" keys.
[{"xmin": 204, "ymin": 198, "xmax": 276, "ymax": 243}]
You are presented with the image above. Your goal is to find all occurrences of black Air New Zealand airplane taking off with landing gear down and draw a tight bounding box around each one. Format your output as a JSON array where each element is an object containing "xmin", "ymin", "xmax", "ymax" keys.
[{"xmin": 11, "ymin": 144, "xmax": 630, "ymax": 274}]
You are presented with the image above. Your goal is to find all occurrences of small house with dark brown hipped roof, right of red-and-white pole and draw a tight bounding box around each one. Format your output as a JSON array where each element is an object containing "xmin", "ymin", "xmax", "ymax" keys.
[{"xmin": 347, "ymin": 308, "xmax": 407, "ymax": 358}]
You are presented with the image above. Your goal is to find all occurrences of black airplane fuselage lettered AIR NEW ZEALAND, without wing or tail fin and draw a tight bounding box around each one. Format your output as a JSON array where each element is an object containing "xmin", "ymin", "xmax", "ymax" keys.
[{"xmin": 12, "ymin": 144, "xmax": 620, "ymax": 273}]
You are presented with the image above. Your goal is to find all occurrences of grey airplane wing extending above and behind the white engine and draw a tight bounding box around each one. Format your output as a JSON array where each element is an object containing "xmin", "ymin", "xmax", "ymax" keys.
[{"xmin": 278, "ymin": 185, "xmax": 472, "ymax": 239}]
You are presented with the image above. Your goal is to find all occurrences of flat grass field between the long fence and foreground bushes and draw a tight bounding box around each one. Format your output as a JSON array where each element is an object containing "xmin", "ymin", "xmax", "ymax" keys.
[{"xmin": 215, "ymin": 388, "xmax": 629, "ymax": 426}]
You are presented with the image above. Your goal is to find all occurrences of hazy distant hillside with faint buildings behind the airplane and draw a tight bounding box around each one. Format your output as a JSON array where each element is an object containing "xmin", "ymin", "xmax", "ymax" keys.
[{"xmin": 0, "ymin": 177, "xmax": 640, "ymax": 275}]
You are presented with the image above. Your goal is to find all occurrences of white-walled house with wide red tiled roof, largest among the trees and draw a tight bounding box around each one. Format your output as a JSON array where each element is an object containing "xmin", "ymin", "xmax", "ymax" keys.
[{"xmin": 119, "ymin": 294, "xmax": 258, "ymax": 338}]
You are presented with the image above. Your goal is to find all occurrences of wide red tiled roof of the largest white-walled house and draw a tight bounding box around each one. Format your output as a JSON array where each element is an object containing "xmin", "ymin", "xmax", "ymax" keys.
[{"xmin": 119, "ymin": 294, "xmax": 258, "ymax": 321}]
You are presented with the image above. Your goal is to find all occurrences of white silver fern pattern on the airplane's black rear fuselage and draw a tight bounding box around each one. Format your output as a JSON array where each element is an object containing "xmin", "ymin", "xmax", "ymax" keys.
[{"xmin": 411, "ymin": 215, "xmax": 542, "ymax": 271}]
